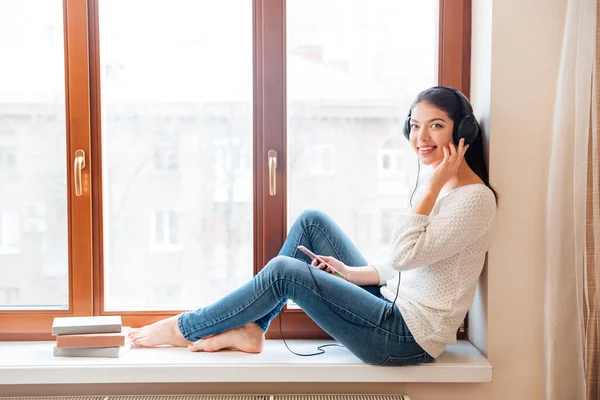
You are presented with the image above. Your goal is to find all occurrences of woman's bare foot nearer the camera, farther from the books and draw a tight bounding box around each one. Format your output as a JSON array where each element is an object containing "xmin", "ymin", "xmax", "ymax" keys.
[{"xmin": 188, "ymin": 322, "xmax": 265, "ymax": 353}]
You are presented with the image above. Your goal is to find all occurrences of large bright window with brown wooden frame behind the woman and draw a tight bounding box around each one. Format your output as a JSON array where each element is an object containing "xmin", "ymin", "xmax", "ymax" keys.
[{"xmin": 0, "ymin": 0, "xmax": 470, "ymax": 339}]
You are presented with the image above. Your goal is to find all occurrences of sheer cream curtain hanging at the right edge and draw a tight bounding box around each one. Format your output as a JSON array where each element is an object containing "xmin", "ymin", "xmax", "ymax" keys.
[{"xmin": 544, "ymin": 0, "xmax": 600, "ymax": 400}]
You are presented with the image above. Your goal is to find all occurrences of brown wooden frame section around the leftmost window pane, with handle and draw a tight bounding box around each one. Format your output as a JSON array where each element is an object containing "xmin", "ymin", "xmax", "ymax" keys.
[{"xmin": 0, "ymin": 0, "xmax": 94, "ymax": 341}]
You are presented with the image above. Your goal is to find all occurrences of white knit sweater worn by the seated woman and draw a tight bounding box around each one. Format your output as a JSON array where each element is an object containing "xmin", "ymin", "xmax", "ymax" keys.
[{"xmin": 373, "ymin": 184, "xmax": 496, "ymax": 358}]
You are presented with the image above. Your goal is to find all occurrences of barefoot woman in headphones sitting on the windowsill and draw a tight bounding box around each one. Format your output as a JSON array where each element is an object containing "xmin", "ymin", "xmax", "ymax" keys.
[{"xmin": 130, "ymin": 87, "xmax": 496, "ymax": 365}]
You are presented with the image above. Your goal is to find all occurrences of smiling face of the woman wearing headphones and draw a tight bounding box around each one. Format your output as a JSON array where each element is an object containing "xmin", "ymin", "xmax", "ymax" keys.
[{"xmin": 410, "ymin": 102, "xmax": 454, "ymax": 167}]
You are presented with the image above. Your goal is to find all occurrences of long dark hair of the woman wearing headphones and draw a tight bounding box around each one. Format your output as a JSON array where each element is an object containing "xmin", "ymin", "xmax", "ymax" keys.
[{"xmin": 410, "ymin": 86, "xmax": 498, "ymax": 203}]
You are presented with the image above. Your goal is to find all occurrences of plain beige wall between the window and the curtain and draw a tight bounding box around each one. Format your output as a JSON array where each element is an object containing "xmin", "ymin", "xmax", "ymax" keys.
[{"xmin": 0, "ymin": 0, "xmax": 567, "ymax": 400}]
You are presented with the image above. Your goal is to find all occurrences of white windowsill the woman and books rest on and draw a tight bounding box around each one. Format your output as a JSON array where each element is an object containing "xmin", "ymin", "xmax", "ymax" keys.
[{"xmin": 0, "ymin": 340, "xmax": 492, "ymax": 385}]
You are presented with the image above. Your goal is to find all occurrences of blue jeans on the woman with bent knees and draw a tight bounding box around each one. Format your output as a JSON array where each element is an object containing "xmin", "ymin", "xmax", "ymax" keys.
[{"xmin": 178, "ymin": 210, "xmax": 433, "ymax": 366}]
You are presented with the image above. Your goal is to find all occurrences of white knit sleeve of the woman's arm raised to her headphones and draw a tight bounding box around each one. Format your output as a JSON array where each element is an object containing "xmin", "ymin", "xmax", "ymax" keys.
[{"xmin": 389, "ymin": 188, "xmax": 496, "ymax": 271}]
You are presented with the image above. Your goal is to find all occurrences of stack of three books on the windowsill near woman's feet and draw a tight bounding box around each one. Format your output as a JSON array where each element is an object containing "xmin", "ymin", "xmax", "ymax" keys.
[{"xmin": 52, "ymin": 316, "xmax": 131, "ymax": 358}]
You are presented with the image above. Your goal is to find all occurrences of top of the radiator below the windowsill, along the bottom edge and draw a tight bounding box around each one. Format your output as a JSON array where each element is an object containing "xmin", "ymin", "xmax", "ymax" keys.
[{"xmin": 0, "ymin": 394, "xmax": 410, "ymax": 400}]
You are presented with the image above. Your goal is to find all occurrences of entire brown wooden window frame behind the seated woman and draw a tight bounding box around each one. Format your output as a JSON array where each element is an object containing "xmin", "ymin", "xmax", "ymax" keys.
[{"xmin": 0, "ymin": 0, "xmax": 471, "ymax": 341}]
